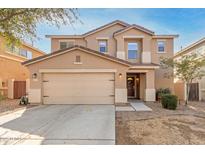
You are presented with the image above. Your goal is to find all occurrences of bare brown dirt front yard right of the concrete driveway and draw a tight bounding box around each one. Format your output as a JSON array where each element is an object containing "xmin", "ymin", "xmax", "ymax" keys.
[{"xmin": 116, "ymin": 102, "xmax": 205, "ymax": 144}]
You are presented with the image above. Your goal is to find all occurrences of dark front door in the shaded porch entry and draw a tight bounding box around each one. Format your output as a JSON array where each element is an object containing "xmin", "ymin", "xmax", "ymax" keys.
[{"xmin": 127, "ymin": 73, "xmax": 140, "ymax": 99}]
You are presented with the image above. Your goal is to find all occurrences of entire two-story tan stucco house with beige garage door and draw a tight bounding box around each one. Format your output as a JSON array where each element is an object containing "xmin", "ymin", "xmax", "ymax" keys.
[{"xmin": 23, "ymin": 20, "xmax": 178, "ymax": 104}]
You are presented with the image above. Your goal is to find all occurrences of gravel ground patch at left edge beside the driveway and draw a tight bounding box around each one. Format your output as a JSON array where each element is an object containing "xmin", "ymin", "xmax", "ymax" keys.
[{"xmin": 0, "ymin": 99, "xmax": 36, "ymax": 115}]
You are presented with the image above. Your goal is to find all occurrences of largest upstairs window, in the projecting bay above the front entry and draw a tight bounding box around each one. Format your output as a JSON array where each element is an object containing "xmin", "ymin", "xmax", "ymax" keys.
[{"xmin": 127, "ymin": 42, "xmax": 138, "ymax": 59}]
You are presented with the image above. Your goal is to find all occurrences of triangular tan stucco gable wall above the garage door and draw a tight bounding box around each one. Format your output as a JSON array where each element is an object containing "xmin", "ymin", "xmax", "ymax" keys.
[{"xmin": 28, "ymin": 49, "xmax": 129, "ymax": 69}]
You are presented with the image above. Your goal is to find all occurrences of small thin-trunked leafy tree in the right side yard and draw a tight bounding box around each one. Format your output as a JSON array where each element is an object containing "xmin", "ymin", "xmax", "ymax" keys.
[{"xmin": 161, "ymin": 53, "xmax": 205, "ymax": 105}]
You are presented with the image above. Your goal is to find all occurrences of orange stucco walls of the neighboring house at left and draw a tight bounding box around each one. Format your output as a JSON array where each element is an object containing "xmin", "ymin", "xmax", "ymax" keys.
[{"xmin": 0, "ymin": 37, "xmax": 45, "ymax": 98}]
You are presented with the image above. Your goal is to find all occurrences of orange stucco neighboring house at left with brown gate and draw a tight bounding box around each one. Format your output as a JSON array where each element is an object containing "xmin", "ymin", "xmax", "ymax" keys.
[{"xmin": 0, "ymin": 37, "xmax": 45, "ymax": 98}]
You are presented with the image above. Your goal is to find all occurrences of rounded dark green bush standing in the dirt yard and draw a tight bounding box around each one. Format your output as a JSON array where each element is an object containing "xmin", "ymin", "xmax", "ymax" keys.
[{"xmin": 162, "ymin": 94, "xmax": 177, "ymax": 110}]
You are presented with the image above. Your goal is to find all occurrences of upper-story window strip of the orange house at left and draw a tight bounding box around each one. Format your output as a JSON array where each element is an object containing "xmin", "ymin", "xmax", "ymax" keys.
[{"xmin": 7, "ymin": 45, "xmax": 32, "ymax": 59}]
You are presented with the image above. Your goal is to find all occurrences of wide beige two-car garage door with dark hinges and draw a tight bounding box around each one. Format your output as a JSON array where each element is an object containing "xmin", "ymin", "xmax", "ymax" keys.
[{"xmin": 43, "ymin": 73, "xmax": 114, "ymax": 104}]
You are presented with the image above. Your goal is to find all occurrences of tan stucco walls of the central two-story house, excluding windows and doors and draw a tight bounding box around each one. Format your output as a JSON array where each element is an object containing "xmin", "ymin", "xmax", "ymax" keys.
[{"xmin": 25, "ymin": 21, "xmax": 176, "ymax": 103}]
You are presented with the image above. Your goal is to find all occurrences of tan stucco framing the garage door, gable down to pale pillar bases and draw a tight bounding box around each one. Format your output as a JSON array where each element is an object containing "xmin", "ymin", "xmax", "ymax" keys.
[{"xmin": 28, "ymin": 50, "xmax": 129, "ymax": 89}]
